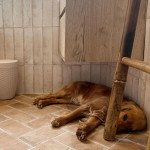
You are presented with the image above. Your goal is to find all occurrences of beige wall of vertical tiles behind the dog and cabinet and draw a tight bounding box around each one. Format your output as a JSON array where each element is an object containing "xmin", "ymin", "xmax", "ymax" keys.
[{"xmin": 0, "ymin": 0, "xmax": 150, "ymax": 125}]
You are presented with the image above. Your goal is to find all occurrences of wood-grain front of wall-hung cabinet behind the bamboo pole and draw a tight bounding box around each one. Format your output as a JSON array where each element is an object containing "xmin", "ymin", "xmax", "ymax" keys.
[{"xmin": 65, "ymin": 0, "xmax": 147, "ymax": 62}]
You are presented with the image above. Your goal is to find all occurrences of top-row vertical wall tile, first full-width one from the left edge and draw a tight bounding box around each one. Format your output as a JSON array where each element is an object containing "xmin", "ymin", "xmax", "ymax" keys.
[{"xmin": 3, "ymin": 0, "xmax": 13, "ymax": 27}]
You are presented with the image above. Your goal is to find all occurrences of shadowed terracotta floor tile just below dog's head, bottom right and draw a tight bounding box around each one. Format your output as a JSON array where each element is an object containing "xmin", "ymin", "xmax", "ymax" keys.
[{"xmin": 127, "ymin": 132, "xmax": 148, "ymax": 146}]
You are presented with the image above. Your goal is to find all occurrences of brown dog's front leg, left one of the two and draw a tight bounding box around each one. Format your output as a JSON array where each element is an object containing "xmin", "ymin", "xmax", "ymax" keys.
[{"xmin": 51, "ymin": 105, "xmax": 90, "ymax": 127}]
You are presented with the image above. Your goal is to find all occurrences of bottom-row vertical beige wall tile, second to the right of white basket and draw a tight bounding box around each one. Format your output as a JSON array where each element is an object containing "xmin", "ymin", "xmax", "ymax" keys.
[{"xmin": 24, "ymin": 65, "xmax": 34, "ymax": 94}]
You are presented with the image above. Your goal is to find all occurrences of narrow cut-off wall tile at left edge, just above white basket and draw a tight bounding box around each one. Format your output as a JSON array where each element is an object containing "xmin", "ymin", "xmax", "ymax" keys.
[{"xmin": 0, "ymin": 29, "xmax": 5, "ymax": 59}]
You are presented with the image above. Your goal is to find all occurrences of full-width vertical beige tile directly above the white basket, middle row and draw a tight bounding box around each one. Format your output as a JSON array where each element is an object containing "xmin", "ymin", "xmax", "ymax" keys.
[{"xmin": 4, "ymin": 28, "xmax": 15, "ymax": 59}]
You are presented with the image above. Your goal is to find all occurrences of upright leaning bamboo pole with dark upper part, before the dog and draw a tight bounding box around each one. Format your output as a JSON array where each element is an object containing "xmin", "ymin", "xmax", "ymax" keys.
[{"xmin": 104, "ymin": 0, "xmax": 141, "ymax": 141}]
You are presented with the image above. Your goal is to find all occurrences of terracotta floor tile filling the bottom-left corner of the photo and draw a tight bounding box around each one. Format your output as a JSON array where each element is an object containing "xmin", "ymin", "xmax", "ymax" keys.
[{"xmin": 0, "ymin": 133, "xmax": 29, "ymax": 150}]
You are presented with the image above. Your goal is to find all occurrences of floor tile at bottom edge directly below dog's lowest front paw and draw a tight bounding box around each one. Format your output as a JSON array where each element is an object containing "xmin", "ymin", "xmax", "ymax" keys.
[{"xmin": 54, "ymin": 132, "xmax": 107, "ymax": 150}]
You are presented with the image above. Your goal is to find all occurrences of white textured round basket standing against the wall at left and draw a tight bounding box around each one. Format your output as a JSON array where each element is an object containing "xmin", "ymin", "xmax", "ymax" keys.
[{"xmin": 0, "ymin": 59, "xmax": 18, "ymax": 100}]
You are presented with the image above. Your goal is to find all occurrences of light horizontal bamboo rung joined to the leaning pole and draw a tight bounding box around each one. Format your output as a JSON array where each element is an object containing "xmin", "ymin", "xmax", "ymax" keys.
[{"xmin": 121, "ymin": 57, "xmax": 150, "ymax": 74}]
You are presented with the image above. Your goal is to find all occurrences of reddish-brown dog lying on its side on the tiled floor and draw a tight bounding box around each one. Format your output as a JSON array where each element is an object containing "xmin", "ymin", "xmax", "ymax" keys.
[{"xmin": 34, "ymin": 82, "xmax": 147, "ymax": 141}]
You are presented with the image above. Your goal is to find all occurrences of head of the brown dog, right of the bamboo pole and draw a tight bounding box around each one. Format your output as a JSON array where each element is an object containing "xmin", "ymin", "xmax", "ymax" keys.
[{"xmin": 117, "ymin": 101, "xmax": 147, "ymax": 132}]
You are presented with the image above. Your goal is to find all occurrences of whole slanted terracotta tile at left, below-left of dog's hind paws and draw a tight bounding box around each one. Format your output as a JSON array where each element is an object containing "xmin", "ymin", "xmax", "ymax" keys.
[{"xmin": 5, "ymin": 109, "xmax": 35, "ymax": 123}]
